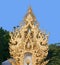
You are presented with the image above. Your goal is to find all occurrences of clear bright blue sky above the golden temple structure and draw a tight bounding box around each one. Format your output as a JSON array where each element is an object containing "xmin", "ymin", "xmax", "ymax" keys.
[{"xmin": 0, "ymin": 0, "xmax": 60, "ymax": 43}]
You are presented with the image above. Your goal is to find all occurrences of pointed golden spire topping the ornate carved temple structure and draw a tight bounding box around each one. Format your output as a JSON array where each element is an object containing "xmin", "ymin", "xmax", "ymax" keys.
[{"xmin": 24, "ymin": 7, "xmax": 36, "ymax": 24}]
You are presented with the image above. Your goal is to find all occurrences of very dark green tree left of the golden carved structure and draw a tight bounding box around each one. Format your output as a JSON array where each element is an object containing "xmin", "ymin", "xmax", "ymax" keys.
[{"xmin": 0, "ymin": 27, "xmax": 10, "ymax": 63}]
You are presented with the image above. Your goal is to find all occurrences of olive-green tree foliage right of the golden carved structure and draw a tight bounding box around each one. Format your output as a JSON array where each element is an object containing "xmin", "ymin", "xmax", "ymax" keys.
[{"xmin": 48, "ymin": 43, "xmax": 60, "ymax": 65}]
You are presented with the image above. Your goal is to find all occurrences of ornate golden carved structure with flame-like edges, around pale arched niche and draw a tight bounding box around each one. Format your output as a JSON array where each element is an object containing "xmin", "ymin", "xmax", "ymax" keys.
[{"xmin": 9, "ymin": 8, "xmax": 48, "ymax": 65}]
